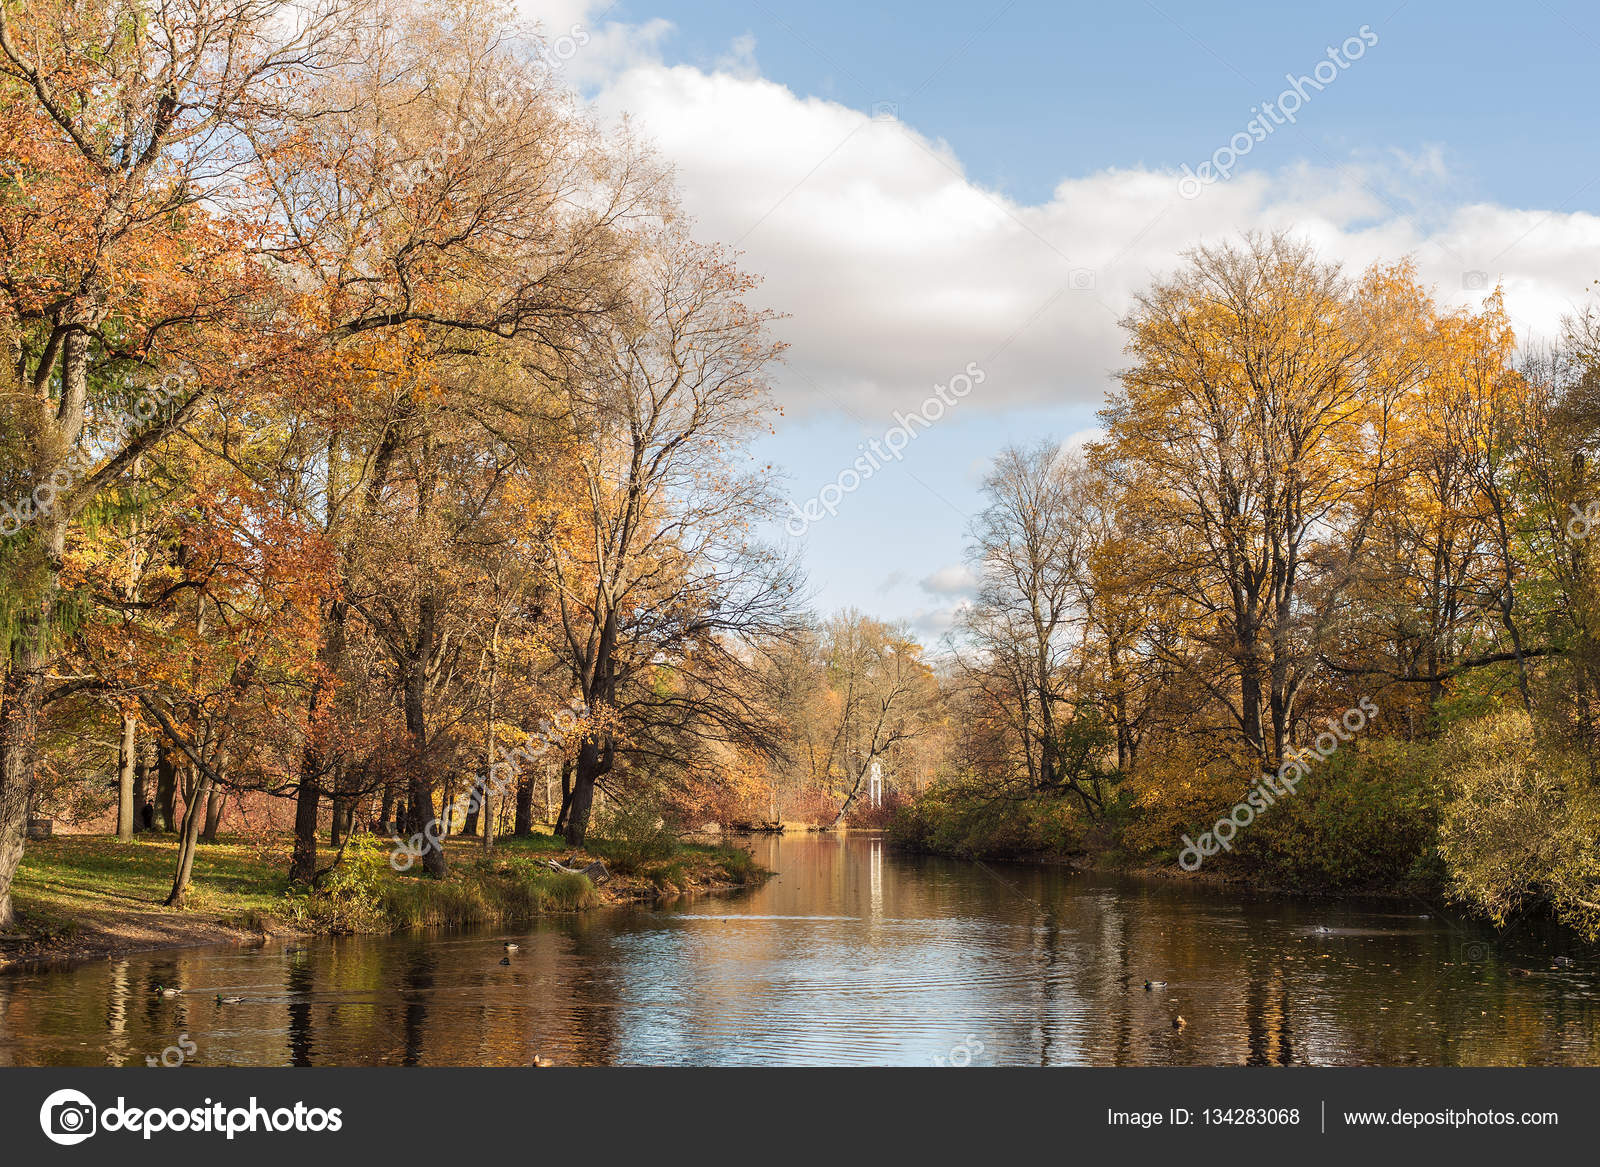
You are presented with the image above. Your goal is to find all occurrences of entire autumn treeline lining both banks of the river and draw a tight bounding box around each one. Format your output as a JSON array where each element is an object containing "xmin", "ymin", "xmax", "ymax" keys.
[{"xmin": 0, "ymin": 0, "xmax": 1600, "ymax": 930}]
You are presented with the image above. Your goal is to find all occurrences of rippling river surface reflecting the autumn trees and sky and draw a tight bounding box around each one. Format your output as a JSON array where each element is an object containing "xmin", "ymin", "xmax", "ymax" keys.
[{"xmin": 0, "ymin": 834, "xmax": 1600, "ymax": 1066}]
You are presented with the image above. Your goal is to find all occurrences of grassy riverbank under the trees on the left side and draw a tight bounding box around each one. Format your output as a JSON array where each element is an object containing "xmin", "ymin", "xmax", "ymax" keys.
[{"xmin": 0, "ymin": 834, "xmax": 773, "ymax": 972}]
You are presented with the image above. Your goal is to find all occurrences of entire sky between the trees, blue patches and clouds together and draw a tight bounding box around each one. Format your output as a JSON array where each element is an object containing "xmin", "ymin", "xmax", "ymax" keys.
[{"xmin": 518, "ymin": 0, "xmax": 1600, "ymax": 642}]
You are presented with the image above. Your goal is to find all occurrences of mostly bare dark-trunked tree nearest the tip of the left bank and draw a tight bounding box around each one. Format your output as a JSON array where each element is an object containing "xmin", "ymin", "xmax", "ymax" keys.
[{"xmin": 547, "ymin": 224, "xmax": 795, "ymax": 845}]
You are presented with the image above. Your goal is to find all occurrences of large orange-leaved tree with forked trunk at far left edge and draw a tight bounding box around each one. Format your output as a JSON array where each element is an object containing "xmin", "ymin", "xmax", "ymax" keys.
[{"xmin": 0, "ymin": 0, "xmax": 356, "ymax": 924}]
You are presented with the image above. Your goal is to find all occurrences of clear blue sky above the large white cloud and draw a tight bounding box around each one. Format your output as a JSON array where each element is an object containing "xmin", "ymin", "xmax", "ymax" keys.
[{"xmin": 636, "ymin": 0, "xmax": 1600, "ymax": 208}]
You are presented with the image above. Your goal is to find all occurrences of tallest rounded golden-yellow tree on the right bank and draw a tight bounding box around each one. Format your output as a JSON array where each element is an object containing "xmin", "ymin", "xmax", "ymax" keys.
[{"xmin": 1096, "ymin": 235, "xmax": 1416, "ymax": 768}]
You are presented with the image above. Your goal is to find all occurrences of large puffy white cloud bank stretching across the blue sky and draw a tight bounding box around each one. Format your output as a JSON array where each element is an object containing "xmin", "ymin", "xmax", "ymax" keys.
[{"xmin": 534, "ymin": 2, "xmax": 1600, "ymax": 418}]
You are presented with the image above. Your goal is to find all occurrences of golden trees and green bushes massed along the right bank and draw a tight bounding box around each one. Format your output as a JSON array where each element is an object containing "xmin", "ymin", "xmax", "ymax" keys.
[{"xmin": 899, "ymin": 235, "xmax": 1600, "ymax": 935}]
